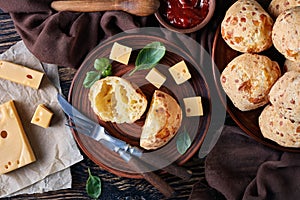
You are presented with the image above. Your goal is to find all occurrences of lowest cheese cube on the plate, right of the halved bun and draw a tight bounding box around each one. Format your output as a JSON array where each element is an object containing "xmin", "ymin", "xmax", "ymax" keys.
[{"xmin": 183, "ymin": 96, "xmax": 203, "ymax": 117}]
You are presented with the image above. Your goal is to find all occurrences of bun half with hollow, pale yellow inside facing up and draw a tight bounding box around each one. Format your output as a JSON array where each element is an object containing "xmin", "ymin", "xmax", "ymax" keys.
[{"xmin": 89, "ymin": 76, "xmax": 147, "ymax": 123}]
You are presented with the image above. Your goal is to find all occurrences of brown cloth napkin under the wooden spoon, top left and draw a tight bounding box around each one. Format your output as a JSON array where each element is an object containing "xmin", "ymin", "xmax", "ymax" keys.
[{"xmin": 0, "ymin": 0, "xmax": 146, "ymax": 68}]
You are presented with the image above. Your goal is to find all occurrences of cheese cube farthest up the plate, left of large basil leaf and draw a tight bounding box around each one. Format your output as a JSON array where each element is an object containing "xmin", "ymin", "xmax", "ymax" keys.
[{"xmin": 109, "ymin": 42, "xmax": 132, "ymax": 65}]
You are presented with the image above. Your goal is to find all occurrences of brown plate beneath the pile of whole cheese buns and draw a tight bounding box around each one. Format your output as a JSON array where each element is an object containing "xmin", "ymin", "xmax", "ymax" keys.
[{"xmin": 212, "ymin": 27, "xmax": 300, "ymax": 152}]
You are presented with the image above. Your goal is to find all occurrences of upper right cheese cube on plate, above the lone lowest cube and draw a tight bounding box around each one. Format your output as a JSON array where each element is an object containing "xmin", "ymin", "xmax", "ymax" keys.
[{"xmin": 169, "ymin": 60, "xmax": 192, "ymax": 85}]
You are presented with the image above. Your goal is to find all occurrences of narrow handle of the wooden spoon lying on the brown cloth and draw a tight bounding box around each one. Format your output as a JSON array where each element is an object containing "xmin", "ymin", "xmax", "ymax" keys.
[{"xmin": 51, "ymin": 0, "xmax": 122, "ymax": 12}]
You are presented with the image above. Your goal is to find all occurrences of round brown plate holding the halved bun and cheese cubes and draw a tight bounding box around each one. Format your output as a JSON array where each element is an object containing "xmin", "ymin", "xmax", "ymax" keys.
[{"xmin": 69, "ymin": 30, "xmax": 211, "ymax": 178}]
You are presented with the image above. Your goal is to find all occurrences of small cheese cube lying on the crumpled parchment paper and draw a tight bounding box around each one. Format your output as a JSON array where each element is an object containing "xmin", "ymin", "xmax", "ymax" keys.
[{"xmin": 31, "ymin": 104, "xmax": 53, "ymax": 128}]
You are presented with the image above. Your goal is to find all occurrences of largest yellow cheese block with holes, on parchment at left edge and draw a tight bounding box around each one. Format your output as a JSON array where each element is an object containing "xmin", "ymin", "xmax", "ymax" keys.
[{"xmin": 0, "ymin": 100, "xmax": 35, "ymax": 174}]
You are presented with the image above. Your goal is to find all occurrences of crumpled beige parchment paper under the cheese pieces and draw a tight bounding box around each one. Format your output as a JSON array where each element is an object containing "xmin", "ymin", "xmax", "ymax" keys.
[{"xmin": 0, "ymin": 41, "xmax": 83, "ymax": 197}]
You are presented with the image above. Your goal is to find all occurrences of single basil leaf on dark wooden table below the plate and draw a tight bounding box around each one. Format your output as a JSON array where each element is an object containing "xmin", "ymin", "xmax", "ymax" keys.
[{"xmin": 85, "ymin": 168, "xmax": 101, "ymax": 199}]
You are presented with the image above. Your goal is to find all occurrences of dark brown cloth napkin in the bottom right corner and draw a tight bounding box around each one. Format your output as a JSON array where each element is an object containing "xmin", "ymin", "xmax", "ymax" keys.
[{"xmin": 199, "ymin": 126, "xmax": 300, "ymax": 200}]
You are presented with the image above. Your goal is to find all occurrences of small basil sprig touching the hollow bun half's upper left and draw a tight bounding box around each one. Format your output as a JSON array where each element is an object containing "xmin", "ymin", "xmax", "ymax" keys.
[{"xmin": 83, "ymin": 58, "xmax": 112, "ymax": 88}]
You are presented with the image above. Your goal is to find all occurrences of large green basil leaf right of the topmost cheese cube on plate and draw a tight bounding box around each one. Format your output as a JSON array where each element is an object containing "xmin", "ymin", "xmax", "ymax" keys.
[{"xmin": 129, "ymin": 42, "xmax": 166, "ymax": 76}]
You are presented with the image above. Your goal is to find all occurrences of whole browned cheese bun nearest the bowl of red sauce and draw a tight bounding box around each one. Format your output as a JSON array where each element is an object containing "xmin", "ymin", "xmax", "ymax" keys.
[{"xmin": 221, "ymin": 0, "xmax": 273, "ymax": 53}]
